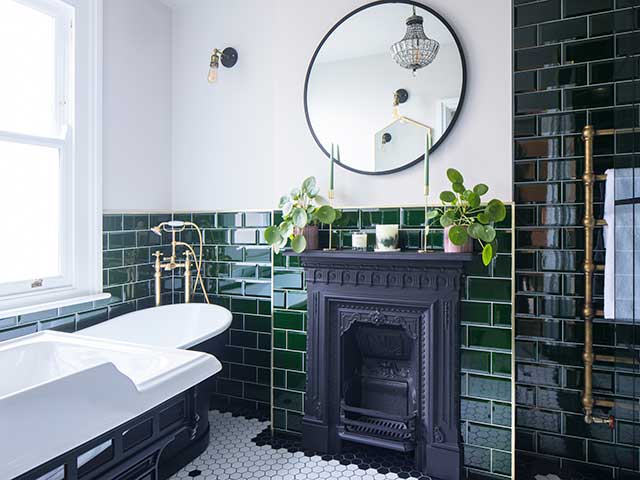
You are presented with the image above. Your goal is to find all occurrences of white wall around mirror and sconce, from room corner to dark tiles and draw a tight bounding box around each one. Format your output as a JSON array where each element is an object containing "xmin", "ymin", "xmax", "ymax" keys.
[{"xmin": 168, "ymin": 0, "xmax": 512, "ymax": 210}]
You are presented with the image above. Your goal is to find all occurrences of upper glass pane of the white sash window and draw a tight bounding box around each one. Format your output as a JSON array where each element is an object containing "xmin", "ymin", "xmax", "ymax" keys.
[{"xmin": 0, "ymin": 0, "xmax": 57, "ymax": 136}]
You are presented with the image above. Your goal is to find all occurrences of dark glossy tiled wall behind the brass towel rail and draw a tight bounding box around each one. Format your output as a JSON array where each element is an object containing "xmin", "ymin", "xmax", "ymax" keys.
[{"xmin": 512, "ymin": 0, "xmax": 640, "ymax": 480}]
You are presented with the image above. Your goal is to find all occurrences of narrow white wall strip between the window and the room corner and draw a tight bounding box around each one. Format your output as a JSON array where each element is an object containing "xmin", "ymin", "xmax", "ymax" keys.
[{"xmin": 103, "ymin": 0, "xmax": 172, "ymax": 211}]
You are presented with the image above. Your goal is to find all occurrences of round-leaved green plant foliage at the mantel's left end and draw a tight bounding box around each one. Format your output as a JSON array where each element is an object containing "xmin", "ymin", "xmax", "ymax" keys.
[{"xmin": 264, "ymin": 177, "xmax": 341, "ymax": 253}]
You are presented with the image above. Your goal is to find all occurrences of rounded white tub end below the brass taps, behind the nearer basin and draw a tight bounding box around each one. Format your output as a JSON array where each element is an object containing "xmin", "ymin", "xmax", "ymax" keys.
[{"xmin": 78, "ymin": 303, "xmax": 232, "ymax": 353}]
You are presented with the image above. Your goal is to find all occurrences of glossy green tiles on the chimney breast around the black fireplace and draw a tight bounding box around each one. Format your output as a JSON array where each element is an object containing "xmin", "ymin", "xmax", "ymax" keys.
[{"xmin": 273, "ymin": 208, "xmax": 512, "ymax": 478}]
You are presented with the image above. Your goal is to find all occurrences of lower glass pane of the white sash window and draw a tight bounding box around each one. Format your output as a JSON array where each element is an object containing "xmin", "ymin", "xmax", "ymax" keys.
[{"xmin": 0, "ymin": 140, "xmax": 60, "ymax": 284}]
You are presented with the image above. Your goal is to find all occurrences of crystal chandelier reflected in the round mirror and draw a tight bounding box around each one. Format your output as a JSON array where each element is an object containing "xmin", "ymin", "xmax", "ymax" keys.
[{"xmin": 391, "ymin": 6, "xmax": 440, "ymax": 75}]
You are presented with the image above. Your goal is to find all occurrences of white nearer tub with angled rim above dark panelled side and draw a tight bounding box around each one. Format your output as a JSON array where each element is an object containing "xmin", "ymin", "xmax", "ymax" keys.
[{"xmin": 0, "ymin": 332, "xmax": 222, "ymax": 479}]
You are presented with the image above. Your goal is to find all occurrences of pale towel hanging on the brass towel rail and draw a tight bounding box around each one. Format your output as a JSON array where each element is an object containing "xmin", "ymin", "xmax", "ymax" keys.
[{"xmin": 604, "ymin": 168, "xmax": 640, "ymax": 321}]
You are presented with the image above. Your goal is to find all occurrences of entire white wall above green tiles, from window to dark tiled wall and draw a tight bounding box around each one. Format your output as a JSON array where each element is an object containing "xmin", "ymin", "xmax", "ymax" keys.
[{"xmin": 104, "ymin": 0, "xmax": 512, "ymax": 211}]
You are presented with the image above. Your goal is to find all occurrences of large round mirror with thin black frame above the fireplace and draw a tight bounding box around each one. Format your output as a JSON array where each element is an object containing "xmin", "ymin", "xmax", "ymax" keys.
[{"xmin": 304, "ymin": 0, "xmax": 465, "ymax": 175}]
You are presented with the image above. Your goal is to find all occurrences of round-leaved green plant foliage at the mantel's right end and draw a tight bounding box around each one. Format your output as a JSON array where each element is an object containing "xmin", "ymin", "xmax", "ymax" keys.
[{"xmin": 428, "ymin": 168, "xmax": 507, "ymax": 266}]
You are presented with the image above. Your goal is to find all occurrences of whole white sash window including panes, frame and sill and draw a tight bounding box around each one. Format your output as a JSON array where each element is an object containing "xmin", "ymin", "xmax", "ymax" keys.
[{"xmin": 0, "ymin": 0, "xmax": 102, "ymax": 318}]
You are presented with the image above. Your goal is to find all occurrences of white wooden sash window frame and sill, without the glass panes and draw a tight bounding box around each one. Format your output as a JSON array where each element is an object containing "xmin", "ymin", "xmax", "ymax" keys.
[{"xmin": 0, "ymin": 0, "xmax": 108, "ymax": 318}]
